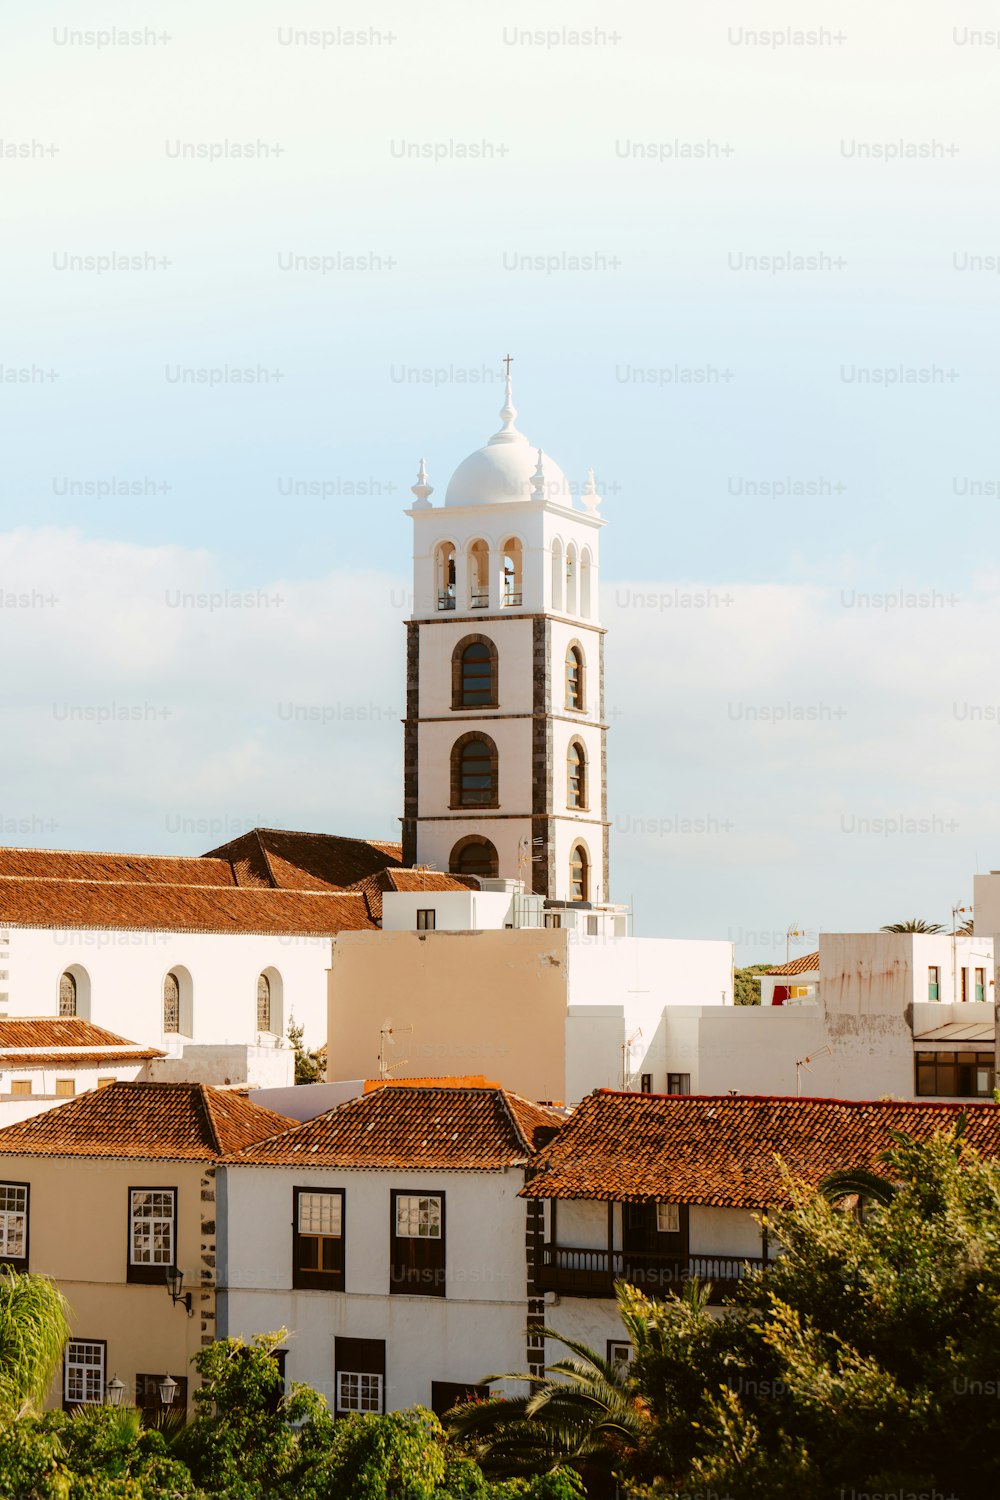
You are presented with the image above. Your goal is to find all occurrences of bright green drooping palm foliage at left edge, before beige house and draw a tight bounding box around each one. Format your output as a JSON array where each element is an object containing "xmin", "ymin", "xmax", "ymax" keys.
[{"xmin": 0, "ymin": 1271, "xmax": 69, "ymax": 1418}]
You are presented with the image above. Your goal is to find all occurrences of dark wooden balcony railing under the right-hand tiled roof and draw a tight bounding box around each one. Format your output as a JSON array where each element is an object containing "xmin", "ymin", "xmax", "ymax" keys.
[{"xmin": 538, "ymin": 1245, "xmax": 765, "ymax": 1302}]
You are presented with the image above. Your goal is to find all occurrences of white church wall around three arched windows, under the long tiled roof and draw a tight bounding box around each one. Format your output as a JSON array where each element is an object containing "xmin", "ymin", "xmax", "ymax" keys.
[{"xmin": 6, "ymin": 927, "xmax": 330, "ymax": 1047}]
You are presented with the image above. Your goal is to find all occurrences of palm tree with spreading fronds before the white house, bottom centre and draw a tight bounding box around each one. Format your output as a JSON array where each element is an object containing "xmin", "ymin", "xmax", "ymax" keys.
[{"xmin": 445, "ymin": 1329, "xmax": 649, "ymax": 1478}]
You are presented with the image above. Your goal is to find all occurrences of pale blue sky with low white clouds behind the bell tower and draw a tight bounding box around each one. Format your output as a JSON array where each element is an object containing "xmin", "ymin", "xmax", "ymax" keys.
[{"xmin": 0, "ymin": 0, "xmax": 1000, "ymax": 962}]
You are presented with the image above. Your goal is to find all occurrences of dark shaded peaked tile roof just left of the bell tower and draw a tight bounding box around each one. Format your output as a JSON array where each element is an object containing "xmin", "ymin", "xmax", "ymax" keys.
[{"xmin": 205, "ymin": 828, "xmax": 402, "ymax": 891}]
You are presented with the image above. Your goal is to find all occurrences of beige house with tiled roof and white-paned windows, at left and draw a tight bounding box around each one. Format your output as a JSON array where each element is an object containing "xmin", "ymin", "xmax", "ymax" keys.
[{"xmin": 0, "ymin": 1083, "xmax": 295, "ymax": 1412}]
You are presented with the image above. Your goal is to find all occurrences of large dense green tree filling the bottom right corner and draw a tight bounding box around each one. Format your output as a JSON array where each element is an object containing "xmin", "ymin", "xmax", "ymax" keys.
[{"xmin": 619, "ymin": 1133, "xmax": 1000, "ymax": 1500}]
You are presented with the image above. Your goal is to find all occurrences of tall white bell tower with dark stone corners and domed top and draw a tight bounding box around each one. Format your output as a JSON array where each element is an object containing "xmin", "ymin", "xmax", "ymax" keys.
[{"xmin": 403, "ymin": 363, "xmax": 609, "ymax": 903}]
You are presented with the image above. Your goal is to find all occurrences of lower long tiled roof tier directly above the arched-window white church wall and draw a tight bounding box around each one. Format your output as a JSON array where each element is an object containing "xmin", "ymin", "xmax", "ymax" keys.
[{"xmin": 0, "ymin": 879, "xmax": 373, "ymax": 935}]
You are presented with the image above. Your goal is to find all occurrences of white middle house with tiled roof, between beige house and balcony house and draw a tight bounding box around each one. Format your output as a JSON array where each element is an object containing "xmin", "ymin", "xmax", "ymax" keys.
[{"xmin": 216, "ymin": 1086, "xmax": 562, "ymax": 1413}]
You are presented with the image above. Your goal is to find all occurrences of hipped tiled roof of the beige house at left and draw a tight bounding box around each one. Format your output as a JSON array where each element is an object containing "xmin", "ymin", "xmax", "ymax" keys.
[{"xmin": 0, "ymin": 1083, "xmax": 295, "ymax": 1161}]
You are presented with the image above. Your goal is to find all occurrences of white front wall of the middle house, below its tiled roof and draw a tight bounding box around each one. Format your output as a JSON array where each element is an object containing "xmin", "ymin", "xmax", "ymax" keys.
[{"xmin": 217, "ymin": 1166, "xmax": 528, "ymax": 1410}]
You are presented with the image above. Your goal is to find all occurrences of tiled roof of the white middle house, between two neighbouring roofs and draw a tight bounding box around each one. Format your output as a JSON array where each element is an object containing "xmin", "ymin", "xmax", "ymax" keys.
[{"xmin": 229, "ymin": 1086, "xmax": 562, "ymax": 1172}]
